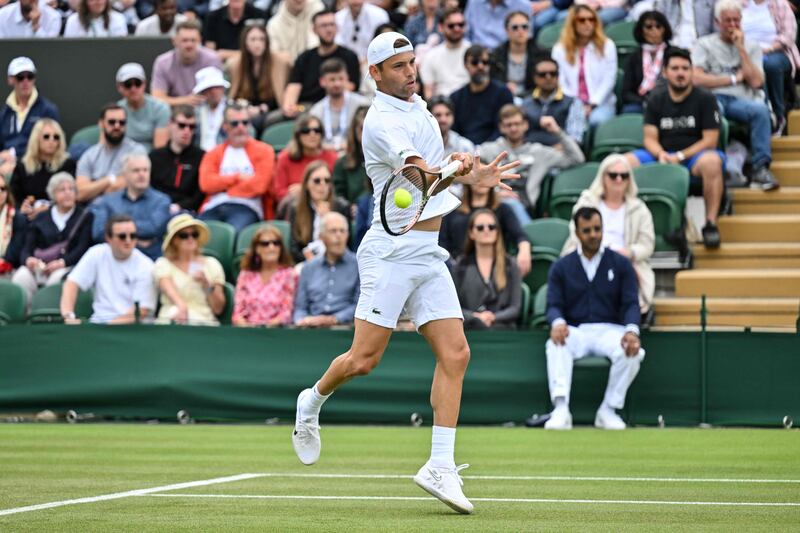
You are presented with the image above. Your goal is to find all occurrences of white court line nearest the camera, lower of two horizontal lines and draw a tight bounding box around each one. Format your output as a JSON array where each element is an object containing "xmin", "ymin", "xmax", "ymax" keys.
[{"xmin": 143, "ymin": 494, "xmax": 800, "ymax": 507}]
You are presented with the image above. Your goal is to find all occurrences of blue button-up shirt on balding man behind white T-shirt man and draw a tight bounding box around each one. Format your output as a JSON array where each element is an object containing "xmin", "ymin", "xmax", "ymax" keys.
[{"xmin": 90, "ymin": 187, "xmax": 170, "ymax": 259}]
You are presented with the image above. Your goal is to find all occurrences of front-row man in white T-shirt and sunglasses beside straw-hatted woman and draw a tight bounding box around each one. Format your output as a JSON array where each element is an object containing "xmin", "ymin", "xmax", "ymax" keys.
[{"xmin": 60, "ymin": 215, "xmax": 156, "ymax": 324}]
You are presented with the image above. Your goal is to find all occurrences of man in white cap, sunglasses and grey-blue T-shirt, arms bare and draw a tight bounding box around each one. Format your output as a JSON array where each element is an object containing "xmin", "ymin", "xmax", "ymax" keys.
[{"xmin": 116, "ymin": 63, "xmax": 169, "ymax": 151}]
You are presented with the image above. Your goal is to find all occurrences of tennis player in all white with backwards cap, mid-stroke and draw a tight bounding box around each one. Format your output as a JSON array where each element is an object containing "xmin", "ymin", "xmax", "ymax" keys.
[{"xmin": 292, "ymin": 32, "xmax": 519, "ymax": 514}]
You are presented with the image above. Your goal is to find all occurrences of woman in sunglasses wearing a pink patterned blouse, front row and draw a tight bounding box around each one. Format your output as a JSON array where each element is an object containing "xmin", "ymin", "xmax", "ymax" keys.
[{"xmin": 233, "ymin": 224, "xmax": 297, "ymax": 326}]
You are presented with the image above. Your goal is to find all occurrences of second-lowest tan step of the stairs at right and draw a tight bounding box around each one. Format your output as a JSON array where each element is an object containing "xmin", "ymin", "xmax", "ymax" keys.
[{"xmin": 675, "ymin": 268, "xmax": 800, "ymax": 298}]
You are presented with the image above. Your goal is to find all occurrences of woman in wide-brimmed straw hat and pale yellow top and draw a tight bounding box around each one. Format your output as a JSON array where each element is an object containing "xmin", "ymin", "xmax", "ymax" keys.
[{"xmin": 153, "ymin": 215, "xmax": 225, "ymax": 326}]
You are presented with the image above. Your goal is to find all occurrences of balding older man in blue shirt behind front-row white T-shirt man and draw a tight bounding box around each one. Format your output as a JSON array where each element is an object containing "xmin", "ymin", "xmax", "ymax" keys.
[{"xmin": 90, "ymin": 153, "xmax": 171, "ymax": 259}]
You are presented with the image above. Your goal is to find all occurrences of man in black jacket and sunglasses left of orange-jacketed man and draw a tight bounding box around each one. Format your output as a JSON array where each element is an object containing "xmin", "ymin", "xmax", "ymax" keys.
[{"xmin": 150, "ymin": 105, "xmax": 205, "ymax": 215}]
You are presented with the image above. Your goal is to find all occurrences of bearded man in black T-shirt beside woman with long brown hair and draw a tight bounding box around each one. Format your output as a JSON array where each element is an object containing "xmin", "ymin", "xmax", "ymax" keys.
[{"xmin": 283, "ymin": 9, "xmax": 360, "ymax": 118}]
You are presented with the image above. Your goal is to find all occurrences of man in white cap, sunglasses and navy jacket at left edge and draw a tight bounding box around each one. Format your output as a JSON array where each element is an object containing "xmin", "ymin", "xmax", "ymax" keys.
[{"xmin": 0, "ymin": 57, "xmax": 58, "ymax": 159}]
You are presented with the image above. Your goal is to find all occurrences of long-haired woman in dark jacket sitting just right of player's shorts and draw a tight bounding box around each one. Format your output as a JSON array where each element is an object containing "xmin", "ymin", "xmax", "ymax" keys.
[{"xmin": 453, "ymin": 208, "xmax": 522, "ymax": 329}]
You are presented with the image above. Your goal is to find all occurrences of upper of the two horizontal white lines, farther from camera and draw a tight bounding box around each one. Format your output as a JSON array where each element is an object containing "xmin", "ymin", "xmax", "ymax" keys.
[{"xmin": 250, "ymin": 472, "xmax": 800, "ymax": 483}]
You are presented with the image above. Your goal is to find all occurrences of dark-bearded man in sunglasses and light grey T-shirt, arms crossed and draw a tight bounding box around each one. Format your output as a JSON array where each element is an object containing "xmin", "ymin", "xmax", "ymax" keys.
[{"xmin": 75, "ymin": 104, "xmax": 147, "ymax": 202}]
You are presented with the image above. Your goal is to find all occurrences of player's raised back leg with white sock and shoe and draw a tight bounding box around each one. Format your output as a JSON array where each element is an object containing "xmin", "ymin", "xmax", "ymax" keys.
[{"xmin": 292, "ymin": 319, "xmax": 394, "ymax": 465}]
